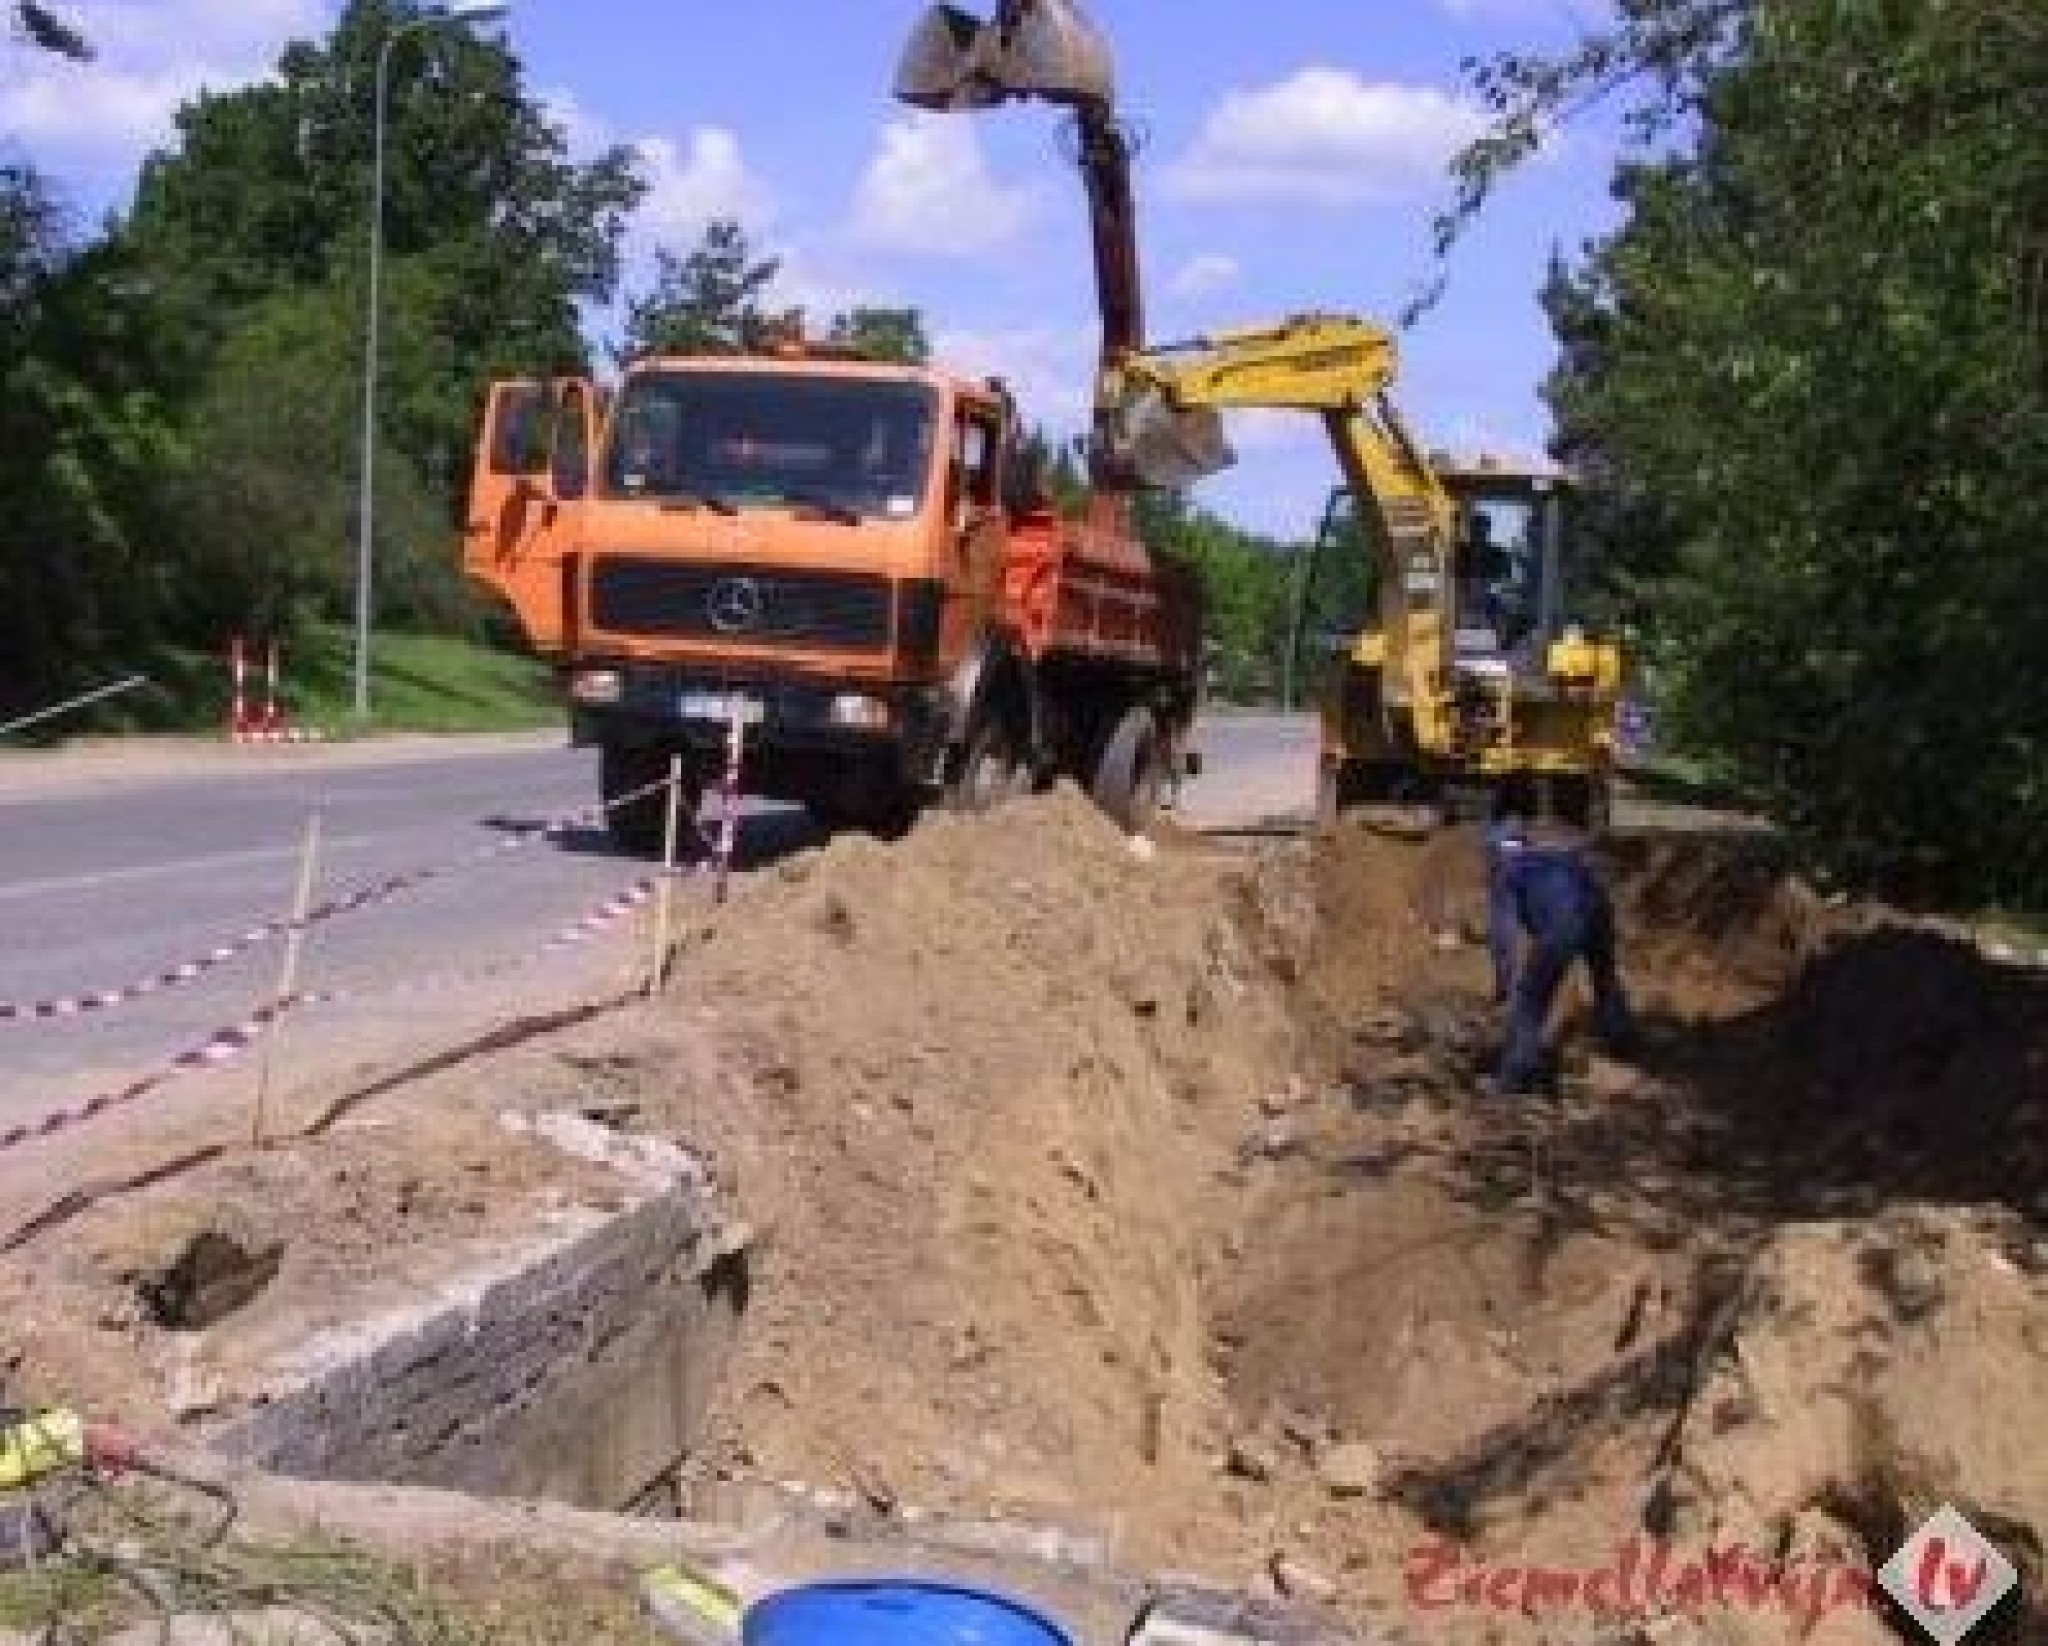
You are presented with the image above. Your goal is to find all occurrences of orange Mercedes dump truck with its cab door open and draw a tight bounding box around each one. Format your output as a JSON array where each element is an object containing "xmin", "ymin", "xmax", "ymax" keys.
[{"xmin": 465, "ymin": 344, "xmax": 1202, "ymax": 850}]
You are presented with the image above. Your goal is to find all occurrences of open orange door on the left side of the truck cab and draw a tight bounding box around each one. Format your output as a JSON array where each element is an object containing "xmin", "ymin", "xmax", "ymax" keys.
[{"xmin": 463, "ymin": 377, "xmax": 598, "ymax": 653}]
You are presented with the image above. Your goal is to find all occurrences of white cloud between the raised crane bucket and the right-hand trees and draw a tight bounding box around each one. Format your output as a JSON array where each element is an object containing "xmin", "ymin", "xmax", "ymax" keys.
[{"xmin": 1167, "ymin": 68, "xmax": 1485, "ymax": 205}]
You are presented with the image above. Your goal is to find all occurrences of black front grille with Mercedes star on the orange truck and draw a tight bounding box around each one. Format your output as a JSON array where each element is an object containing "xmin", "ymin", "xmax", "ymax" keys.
[{"xmin": 590, "ymin": 555, "xmax": 891, "ymax": 651}]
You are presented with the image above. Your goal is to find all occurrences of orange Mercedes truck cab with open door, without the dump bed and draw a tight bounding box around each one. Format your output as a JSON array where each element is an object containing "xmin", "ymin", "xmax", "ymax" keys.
[{"xmin": 465, "ymin": 350, "xmax": 1032, "ymax": 843}]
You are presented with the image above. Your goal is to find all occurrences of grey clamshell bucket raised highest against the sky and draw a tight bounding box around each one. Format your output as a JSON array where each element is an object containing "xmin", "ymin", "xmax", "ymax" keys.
[{"xmin": 895, "ymin": 0, "xmax": 1116, "ymax": 109}]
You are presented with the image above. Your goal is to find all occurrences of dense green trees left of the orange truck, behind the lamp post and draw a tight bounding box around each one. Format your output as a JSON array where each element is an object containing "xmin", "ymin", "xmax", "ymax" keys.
[{"xmin": 0, "ymin": 0, "xmax": 645, "ymax": 732}]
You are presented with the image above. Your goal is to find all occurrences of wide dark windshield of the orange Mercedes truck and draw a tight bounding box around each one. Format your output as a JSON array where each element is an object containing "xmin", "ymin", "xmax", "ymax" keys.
[{"xmin": 604, "ymin": 371, "xmax": 934, "ymax": 520}]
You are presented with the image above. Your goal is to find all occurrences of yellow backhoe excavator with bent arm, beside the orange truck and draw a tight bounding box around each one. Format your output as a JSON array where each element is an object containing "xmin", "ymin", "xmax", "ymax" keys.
[{"xmin": 1098, "ymin": 315, "xmax": 1622, "ymax": 825}]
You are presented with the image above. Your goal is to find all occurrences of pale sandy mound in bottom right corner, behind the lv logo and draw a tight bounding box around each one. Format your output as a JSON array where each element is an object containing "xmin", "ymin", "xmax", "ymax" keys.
[{"xmin": 1665, "ymin": 1208, "xmax": 2048, "ymax": 1642}]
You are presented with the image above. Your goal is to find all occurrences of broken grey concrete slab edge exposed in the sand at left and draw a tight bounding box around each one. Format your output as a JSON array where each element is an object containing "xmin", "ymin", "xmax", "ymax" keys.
[{"xmin": 199, "ymin": 1118, "xmax": 748, "ymax": 1509}]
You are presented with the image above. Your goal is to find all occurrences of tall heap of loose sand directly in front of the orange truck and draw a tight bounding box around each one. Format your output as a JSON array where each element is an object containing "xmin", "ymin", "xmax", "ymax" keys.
[{"xmin": 536, "ymin": 790, "xmax": 1294, "ymax": 1542}]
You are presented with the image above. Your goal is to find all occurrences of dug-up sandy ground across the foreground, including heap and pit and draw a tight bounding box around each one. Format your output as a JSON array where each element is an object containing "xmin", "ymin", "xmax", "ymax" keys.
[{"xmin": 0, "ymin": 792, "xmax": 2048, "ymax": 1642}]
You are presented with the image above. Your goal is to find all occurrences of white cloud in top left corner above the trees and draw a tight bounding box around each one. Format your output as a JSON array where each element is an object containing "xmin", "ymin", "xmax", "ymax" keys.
[{"xmin": 0, "ymin": 0, "xmax": 326, "ymax": 160}]
